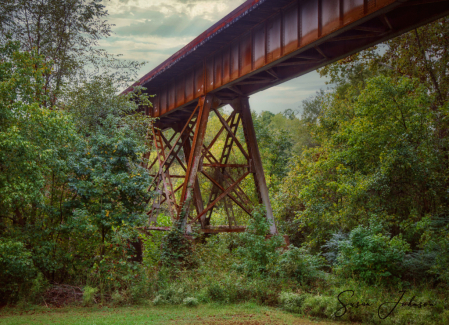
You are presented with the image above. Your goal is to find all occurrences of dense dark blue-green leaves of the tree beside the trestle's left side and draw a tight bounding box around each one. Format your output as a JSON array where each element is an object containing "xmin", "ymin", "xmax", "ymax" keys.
[{"xmin": 69, "ymin": 121, "xmax": 150, "ymax": 248}]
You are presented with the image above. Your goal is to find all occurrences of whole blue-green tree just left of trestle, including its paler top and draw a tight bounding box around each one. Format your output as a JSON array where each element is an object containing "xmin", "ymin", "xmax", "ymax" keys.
[{"xmin": 67, "ymin": 78, "xmax": 152, "ymax": 255}]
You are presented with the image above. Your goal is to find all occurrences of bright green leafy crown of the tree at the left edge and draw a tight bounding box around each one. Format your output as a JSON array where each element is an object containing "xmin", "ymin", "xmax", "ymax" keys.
[{"xmin": 0, "ymin": 42, "xmax": 78, "ymax": 218}]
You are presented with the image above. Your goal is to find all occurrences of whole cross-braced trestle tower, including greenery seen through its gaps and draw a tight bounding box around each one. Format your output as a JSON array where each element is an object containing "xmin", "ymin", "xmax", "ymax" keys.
[{"xmin": 145, "ymin": 95, "xmax": 277, "ymax": 234}]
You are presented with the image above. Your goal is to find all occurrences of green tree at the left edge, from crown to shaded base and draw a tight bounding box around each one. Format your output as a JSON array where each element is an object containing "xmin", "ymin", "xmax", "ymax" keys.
[{"xmin": 0, "ymin": 42, "xmax": 80, "ymax": 284}]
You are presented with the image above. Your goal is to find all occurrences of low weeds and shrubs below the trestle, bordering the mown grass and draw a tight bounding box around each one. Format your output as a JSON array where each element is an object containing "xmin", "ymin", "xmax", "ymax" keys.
[{"xmin": 4, "ymin": 213, "xmax": 449, "ymax": 325}]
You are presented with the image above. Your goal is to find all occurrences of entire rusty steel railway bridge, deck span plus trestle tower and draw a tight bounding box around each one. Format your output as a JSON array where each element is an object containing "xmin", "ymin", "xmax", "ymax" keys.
[{"xmin": 125, "ymin": 0, "xmax": 449, "ymax": 234}]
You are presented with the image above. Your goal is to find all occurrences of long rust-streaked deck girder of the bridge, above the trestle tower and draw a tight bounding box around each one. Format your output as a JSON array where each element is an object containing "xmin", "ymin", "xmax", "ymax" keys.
[{"xmin": 125, "ymin": 0, "xmax": 449, "ymax": 121}]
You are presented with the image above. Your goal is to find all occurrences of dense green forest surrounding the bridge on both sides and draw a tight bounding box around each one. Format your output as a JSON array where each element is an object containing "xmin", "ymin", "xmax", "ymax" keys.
[{"xmin": 0, "ymin": 0, "xmax": 449, "ymax": 324}]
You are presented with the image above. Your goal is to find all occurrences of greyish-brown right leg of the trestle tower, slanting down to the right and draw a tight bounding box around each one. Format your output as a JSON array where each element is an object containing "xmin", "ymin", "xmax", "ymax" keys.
[{"xmin": 231, "ymin": 97, "xmax": 277, "ymax": 235}]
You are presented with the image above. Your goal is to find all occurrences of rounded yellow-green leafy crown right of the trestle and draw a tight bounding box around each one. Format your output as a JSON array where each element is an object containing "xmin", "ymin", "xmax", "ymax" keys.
[{"xmin": 284, "ymin": 77, "xmax": 446, "ymax": 251}]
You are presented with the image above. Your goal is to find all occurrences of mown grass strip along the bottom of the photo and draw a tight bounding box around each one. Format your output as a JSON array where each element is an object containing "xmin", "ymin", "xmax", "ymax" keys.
[{"xmin": 0, "ymin": 304, "xmax": 350, "ymax": 325}]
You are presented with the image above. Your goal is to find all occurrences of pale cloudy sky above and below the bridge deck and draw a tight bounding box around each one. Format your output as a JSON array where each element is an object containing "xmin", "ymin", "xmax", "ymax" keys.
[{"xmin": 100, "ymin": 0, "xmax": 327, "ymax": 114}]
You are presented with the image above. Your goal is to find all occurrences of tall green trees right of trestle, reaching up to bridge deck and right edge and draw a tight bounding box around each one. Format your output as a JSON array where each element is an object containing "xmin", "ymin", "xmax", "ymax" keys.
[{"xmin": 279, "ymin": 19, "xmax": 449, "ymax": 264}]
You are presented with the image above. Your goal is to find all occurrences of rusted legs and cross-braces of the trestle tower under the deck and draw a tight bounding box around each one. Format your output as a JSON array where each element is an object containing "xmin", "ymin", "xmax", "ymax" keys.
[{"xmin": 150, "ymin": 96, "xmax": 276, "ymax": 234}]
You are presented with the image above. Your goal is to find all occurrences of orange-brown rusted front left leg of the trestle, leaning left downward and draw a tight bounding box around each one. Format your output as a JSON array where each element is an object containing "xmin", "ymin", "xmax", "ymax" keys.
[{"xmin": 179, "ymin": 95, "xmax": 213, "ymax": 231}]
